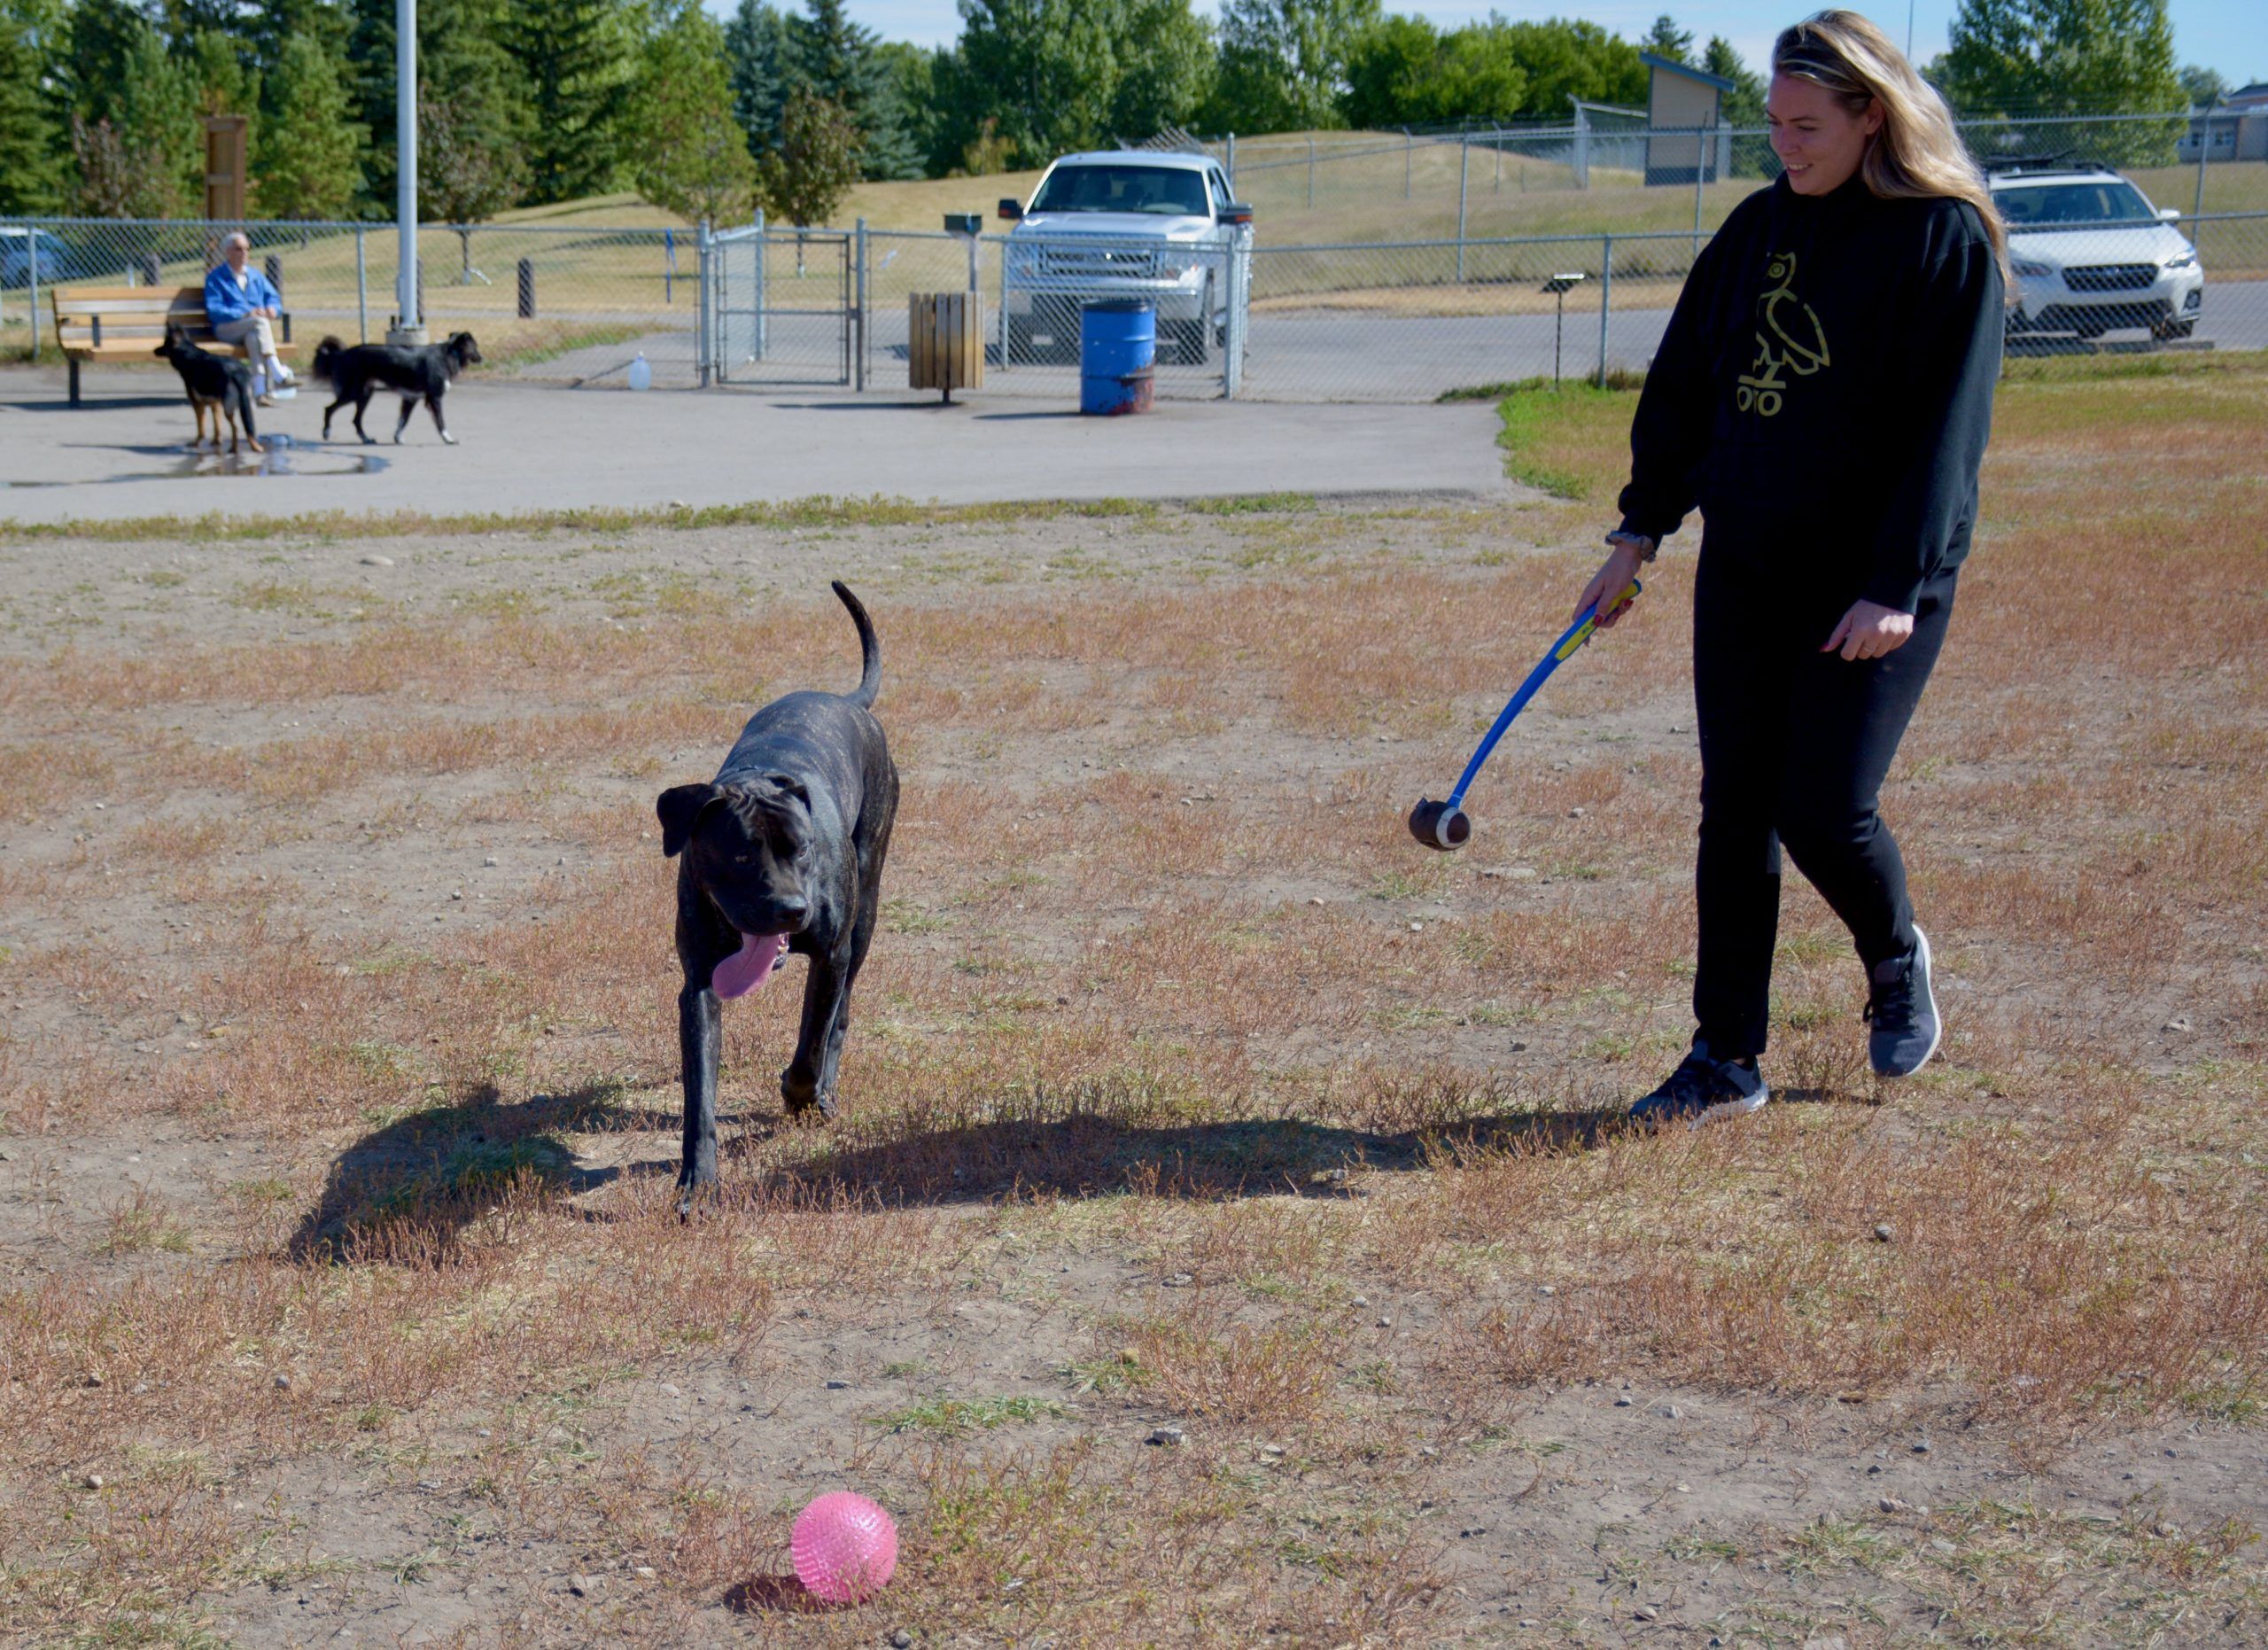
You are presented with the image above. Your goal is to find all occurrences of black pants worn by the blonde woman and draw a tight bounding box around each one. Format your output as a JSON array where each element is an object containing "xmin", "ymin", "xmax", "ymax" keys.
[{"xmin": 1694, "ymin": 541, "xmax": 1957, "ymax": 1060}]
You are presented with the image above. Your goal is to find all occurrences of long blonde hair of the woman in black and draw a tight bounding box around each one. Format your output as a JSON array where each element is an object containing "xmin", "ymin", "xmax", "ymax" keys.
[{"xmin": 1771, "ymin": 12, "xmax": 2009, "ymax": 279}]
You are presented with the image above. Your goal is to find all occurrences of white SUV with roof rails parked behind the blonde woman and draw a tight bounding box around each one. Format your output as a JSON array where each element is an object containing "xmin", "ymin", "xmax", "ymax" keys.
[{"xmin": 1992, "ymin": 163, "xmax": 2204, "ymax": 339}]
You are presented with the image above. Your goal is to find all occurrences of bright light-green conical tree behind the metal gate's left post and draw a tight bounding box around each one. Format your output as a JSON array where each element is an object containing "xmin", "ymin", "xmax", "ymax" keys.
[{"xmin": 624, "ymin": 7, "xmax": 755, "ymax": 222}]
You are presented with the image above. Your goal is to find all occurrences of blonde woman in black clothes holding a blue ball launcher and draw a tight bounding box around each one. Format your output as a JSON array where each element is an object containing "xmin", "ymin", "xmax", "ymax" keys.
[{"xmin": 1576, "ymin": 12, "xmax": 2008, "ymax": 1124}]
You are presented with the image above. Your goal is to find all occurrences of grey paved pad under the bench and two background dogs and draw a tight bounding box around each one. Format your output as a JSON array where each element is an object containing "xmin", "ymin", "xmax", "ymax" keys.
[{"xmin": 0, "ymin": 368, "xmax": 1513, "ymax": 522}]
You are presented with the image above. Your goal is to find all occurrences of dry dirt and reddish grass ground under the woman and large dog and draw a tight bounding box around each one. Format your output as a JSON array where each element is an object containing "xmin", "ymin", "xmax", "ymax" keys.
[{"xmin": 0, "ymin": 406, "xmax": 2268, "ymax": 1647}]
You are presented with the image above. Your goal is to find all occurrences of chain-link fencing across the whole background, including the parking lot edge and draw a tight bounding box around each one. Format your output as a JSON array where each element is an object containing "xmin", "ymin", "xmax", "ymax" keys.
[{"xmin": 0, "ymin": 109, "xmax": 2268, "ymax": 401}]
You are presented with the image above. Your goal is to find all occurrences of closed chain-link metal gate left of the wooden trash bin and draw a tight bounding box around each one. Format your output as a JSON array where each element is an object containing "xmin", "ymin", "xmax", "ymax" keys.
[{"xmin": 705, "ymin": 225, "xmax": 858, "ymax": 385}]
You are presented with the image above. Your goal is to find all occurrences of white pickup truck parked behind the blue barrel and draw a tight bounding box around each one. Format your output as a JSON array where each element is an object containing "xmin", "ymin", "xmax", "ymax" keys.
[{"xmin": 1000, "ymin": 150, "xmax": 1252, "ymax": 365}]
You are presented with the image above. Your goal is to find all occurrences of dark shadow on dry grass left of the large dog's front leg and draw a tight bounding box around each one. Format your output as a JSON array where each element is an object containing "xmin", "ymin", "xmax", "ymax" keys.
[{"xmin": 286, "ymin": 1085, "xmax": 644, "ymax": 1262}]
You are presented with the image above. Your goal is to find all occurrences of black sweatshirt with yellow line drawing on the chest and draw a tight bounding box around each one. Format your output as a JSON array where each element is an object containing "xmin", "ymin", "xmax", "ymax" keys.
[{"xmin": 1621, "ymin": 177, "xmax": 2005, "ymax": 613}]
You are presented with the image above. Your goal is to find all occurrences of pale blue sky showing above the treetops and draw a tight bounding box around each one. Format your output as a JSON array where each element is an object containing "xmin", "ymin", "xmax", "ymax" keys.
[{"xmin": 708, "ymin": 0, "xmax": 2268, "ymax": 86}]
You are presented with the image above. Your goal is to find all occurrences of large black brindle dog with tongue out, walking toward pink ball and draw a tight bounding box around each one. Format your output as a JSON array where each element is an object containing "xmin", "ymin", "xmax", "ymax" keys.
[{"xmin": 656, "ymin": 581, "xmax": 898, "ymax": 1210}]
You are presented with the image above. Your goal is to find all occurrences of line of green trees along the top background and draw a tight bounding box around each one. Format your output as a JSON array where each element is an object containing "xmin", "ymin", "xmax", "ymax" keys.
[{"xmin": 0, "ymin": 0, "xmax": 2211, "ymax": 222}]
